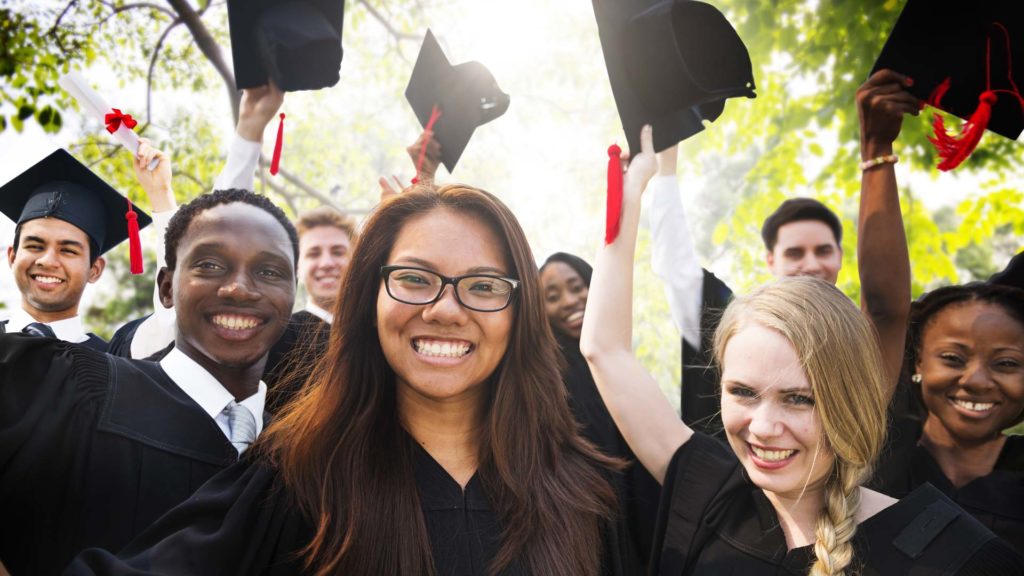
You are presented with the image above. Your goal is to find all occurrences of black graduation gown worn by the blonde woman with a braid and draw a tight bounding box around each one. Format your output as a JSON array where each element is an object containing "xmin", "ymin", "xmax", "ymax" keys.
[{"xmin": 651, "ymin": 433, "xmax": 1024, "ymax": 576}]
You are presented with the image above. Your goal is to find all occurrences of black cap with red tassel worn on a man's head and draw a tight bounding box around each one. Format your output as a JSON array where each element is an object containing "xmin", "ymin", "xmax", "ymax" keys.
[{"xmin": 0, "ymin": 149, "xmax": 153, "ymax": 274}]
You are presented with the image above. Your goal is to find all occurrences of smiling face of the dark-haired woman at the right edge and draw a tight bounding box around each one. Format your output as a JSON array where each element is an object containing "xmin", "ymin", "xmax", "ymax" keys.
[{"xmin": 916, "ymin": 301, "xmax": 1024, "ymax": 443}]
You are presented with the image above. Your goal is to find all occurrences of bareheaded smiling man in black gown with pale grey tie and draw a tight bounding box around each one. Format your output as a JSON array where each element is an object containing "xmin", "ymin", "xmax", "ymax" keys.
[{"xmin": 0, "ymin": 190, "xmax": 298, "ymax": 576}]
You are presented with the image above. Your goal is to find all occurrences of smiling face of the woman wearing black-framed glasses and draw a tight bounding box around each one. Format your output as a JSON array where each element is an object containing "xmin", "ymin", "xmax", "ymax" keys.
[{"xmin": 377, "ymin": 208, "xmax": 514, "ymax": 403}]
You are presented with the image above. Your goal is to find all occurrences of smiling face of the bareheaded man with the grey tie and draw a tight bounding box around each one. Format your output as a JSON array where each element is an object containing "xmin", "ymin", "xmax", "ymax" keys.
[{"xmin": 160, "ymin": 202, "xmax": 295, "ymax": 368}]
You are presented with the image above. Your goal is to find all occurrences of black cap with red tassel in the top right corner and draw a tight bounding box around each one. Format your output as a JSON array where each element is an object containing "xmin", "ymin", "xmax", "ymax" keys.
[{"xmin": 871, "ymin": 0, "xmax": 1024, "ymax": 170}]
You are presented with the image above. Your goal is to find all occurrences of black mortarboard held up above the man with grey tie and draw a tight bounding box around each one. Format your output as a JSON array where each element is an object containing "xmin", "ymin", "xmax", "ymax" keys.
[{"xmin": 227, "ymin": 0, "xmax": 345, "ymax": 92}]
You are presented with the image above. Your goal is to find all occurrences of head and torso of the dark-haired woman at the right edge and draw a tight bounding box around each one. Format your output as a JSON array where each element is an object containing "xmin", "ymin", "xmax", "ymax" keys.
[{"xmin": 877, "ymin": 283, "xmax": 1024, "ymax": 551}]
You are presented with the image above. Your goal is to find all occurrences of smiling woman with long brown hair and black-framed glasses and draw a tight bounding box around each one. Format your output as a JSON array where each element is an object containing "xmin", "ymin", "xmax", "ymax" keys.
[{"xmin": 70, "ymin": 186, "xmax": 639, "ymax": 576}]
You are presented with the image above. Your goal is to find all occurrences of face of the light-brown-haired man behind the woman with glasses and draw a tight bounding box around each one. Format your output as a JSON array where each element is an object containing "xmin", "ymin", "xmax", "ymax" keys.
[{"xmin": 299, "ymin": 225, "xmax": 352, "ymax": 312}]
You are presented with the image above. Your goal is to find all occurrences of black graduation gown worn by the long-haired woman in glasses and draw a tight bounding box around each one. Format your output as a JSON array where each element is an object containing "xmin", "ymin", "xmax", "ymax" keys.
[{"xmin": 66, "ymin": 432, "xmax": 633, "ymax": 576}]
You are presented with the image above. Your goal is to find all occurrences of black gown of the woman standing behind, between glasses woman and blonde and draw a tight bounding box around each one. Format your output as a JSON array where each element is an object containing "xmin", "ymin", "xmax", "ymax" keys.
[{"xmin": 558, "ymin": 335, "xmax": 662, "ymax": 574}]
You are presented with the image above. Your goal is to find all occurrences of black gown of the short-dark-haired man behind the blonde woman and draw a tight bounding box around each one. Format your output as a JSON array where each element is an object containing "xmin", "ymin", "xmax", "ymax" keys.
[{"xmin": 680, "ymin": 270, "xmax": 732, "ymax": 438}]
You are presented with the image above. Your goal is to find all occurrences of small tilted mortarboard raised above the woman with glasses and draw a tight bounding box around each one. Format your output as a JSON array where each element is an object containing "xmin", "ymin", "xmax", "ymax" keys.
[{"xmin": 406, "ymin": 30, "xmax": 509, "ymax": 173}]
